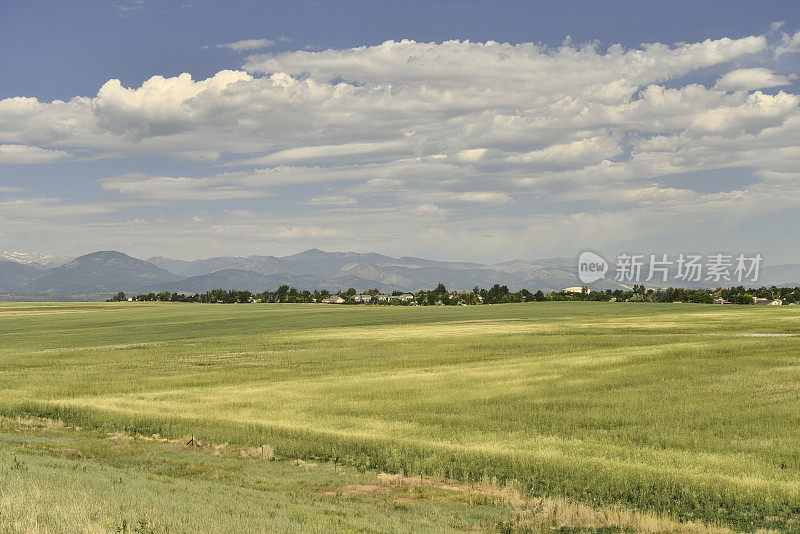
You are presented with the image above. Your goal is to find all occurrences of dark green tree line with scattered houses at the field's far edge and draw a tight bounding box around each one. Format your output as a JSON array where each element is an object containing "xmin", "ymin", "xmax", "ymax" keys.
[{"xmin": 109, "ymin": 284, "xmax": 800, "ymax": 306}]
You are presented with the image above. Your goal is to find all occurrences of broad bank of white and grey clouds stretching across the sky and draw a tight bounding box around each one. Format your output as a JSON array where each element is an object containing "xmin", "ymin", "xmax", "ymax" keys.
[{"xmin": 0, "ymin": 31, "xmax": 800, "ymax": 262}]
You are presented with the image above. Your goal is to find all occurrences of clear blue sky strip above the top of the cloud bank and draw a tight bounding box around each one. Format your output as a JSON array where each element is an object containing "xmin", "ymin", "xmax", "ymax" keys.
[{"xmin": 0, "ymin": 0, "xmax": 800, "ymax": 99}]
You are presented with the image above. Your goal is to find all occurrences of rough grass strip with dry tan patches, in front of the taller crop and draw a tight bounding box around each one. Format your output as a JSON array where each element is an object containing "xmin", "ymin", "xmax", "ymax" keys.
[{"xmin": 0, "ymin": 418, "xmax": 730, "ymax": 534}]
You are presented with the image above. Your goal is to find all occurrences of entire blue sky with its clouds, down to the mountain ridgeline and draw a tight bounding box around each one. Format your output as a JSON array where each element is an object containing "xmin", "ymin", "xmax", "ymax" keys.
[{"xmin": 0, "ymin": 0, "xmax": 800, "ymax": 264}]
